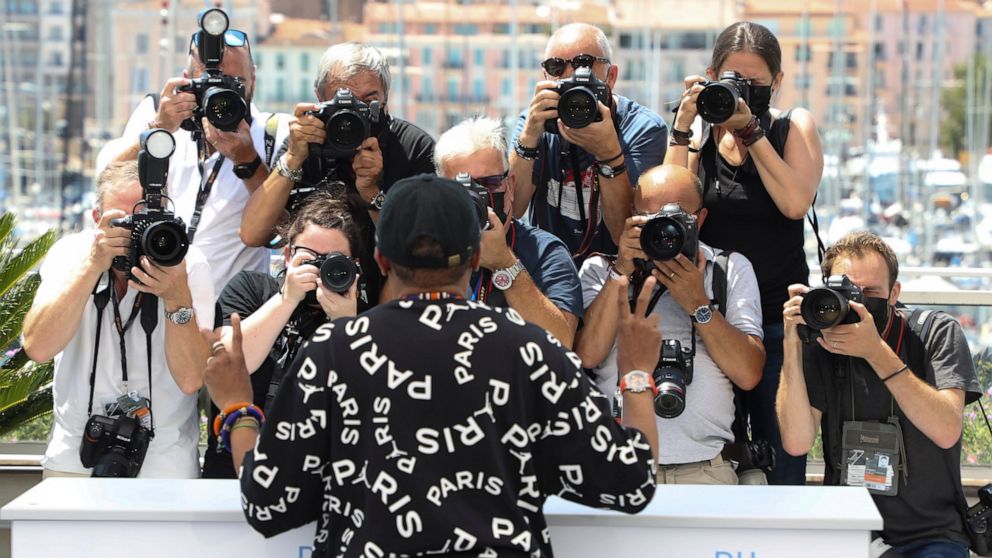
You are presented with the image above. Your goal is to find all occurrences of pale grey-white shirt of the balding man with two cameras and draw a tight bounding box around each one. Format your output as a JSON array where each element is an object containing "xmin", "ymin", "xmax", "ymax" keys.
[{"xmin": 579, "ymin": 242, "xmax": 763, "ymax": 465}]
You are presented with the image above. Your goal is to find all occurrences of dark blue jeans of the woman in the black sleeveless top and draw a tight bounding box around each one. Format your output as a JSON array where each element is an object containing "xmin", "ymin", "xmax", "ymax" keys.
[{"xmin": 744, "ymin": 324, "xmax": 806, "ymax": 485}]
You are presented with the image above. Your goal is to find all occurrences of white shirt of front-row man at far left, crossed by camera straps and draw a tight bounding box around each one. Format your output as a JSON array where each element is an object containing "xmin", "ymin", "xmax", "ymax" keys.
[{"xmin": 36, "ymin": 231, "xmax": 214, "ymax": 478}]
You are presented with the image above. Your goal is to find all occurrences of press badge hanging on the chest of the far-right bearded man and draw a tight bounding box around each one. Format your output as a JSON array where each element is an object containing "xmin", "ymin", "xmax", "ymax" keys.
[{"xmin": 841, "ymin": 417, "xmax": 903, "ymax": 496}]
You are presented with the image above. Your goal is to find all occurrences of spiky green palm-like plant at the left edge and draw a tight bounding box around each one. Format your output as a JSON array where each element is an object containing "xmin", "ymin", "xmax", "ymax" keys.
[{"xmin": 0, "ymin": 213, "xmax": 58, "ymax": 436}]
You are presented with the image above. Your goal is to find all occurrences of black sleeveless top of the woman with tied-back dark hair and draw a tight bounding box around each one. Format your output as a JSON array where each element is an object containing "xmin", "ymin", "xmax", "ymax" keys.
[{"xmin": 699, "ymin": 113, "xmax": 809, "ymax": 325}]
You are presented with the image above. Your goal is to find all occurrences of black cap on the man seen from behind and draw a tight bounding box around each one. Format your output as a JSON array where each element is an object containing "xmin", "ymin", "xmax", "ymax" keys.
[{"xmin": 375, "ymin": 174, "xmax": 482, "ymax": 269}]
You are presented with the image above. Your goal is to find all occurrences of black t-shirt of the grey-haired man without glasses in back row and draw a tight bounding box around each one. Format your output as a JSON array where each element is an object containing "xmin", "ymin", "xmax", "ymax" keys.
[{"xmin": 278, "ymin": 117, "xmax": 435, "ymax": 304}]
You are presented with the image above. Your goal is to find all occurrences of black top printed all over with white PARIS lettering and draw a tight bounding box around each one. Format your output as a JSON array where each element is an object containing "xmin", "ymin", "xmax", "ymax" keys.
[{"xmin": 241, "ymin": 300, "xmax": 654, "ymax": 557}]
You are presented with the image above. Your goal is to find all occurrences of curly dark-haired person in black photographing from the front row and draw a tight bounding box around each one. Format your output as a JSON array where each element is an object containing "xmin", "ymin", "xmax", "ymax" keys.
[{"xmin": 203, "ymin": 194, "xmax": 367, "ymax": 478}]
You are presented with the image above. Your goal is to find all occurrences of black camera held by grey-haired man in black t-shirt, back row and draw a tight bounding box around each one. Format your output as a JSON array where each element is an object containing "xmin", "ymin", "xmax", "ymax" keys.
[{"xmin": 306, "ymin": 89, "xmax": 382, "ymax": 159}]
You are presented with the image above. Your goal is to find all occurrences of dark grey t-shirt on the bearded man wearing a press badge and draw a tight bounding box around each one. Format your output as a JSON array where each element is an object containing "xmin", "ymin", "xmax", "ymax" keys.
[{"xmin": 803, "ymin": 310, "xmax": 982, "ymax": 546}]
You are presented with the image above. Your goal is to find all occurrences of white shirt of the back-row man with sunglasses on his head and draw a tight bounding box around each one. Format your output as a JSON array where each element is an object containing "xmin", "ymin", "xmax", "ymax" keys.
[{"xmin": 114, "ymin": 97, "xmax": 289, "ymax": 293}]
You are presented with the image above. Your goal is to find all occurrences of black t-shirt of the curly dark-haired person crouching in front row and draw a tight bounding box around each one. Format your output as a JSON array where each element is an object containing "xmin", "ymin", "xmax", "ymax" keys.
[{"xmin": 203, "ymin": 271, "xmax": 327, "ymax": 479}]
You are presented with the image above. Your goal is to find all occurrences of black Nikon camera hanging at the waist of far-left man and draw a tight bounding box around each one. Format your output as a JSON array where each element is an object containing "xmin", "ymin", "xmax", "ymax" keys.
[{"xmin": 79, "ymin": 414, "xmax": 153, "ymax": 478}]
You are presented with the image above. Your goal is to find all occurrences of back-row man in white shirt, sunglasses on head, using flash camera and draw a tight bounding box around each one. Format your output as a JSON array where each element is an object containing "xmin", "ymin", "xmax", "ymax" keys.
[{"xmin": 117, "ymin": 10, "xmax": 289, "ymax": 298}]
